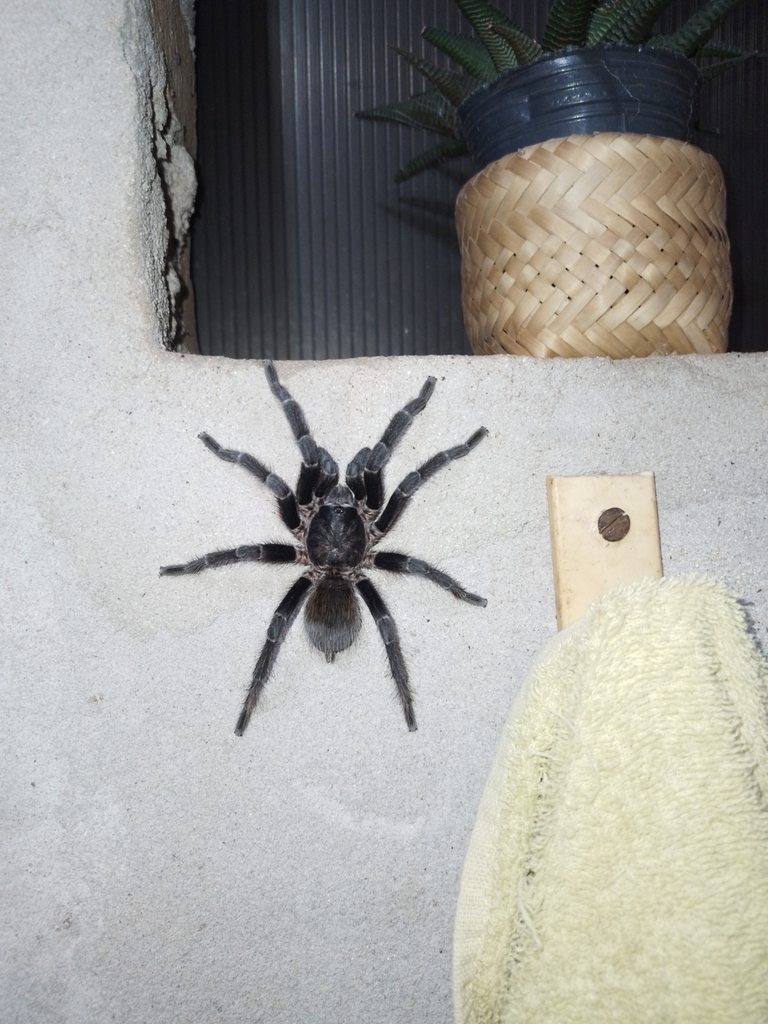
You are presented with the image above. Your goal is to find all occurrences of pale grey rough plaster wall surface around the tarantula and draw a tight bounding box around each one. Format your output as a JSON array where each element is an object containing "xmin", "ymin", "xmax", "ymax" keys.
[{"xmin": 0, "ymin": 0, "xmax": 768, "ymax": 1024}]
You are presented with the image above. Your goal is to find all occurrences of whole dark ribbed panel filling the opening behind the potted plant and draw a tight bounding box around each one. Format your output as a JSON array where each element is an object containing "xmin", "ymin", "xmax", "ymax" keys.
[{"xmin": 193, "ymin": 0, "xmax": 768, "ymax": 358}]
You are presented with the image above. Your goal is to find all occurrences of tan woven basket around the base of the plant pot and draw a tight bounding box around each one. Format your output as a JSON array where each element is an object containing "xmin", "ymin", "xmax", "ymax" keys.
[{"xmin": 456, "ymin": 132, "xmax": 732, "ymax": 358}]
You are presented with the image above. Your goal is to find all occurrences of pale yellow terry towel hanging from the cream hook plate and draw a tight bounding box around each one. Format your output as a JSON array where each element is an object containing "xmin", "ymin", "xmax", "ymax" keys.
[{"xmin": 454, "ymin": 579, "xmax": 768, "ymax": 1024}]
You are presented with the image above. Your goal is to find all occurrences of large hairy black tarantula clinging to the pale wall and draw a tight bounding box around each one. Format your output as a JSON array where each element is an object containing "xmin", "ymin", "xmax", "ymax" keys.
[{"xmin": 160, "ymin": 359, "xmax": 487, "ymax": 736}]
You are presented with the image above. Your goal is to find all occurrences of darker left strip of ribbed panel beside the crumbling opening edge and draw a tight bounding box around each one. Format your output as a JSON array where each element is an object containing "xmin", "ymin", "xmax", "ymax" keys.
[{"xmin": 193, "ymin": 0, "xmax": 288, "ymax": 357}]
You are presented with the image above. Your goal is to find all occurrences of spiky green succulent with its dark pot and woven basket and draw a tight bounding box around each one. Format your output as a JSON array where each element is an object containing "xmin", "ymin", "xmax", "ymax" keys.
[{"xmin": 357, "ymin": 0, "xmax": 753, "ymax": 357}]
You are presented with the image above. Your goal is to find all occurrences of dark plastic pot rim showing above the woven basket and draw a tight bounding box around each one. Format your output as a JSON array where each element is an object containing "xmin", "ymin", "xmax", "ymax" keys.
[{"xmin": 457, "ymin": 45, "xmax": 701, "ymax": 171}]
